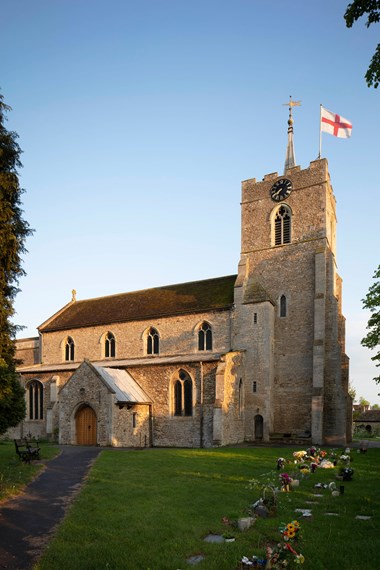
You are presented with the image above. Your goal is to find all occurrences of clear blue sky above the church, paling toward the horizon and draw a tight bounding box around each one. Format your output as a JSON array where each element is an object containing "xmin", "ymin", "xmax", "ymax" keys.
[{"xmin": 0, "ymin": 0, "xmax": 380, "ymax": 403}]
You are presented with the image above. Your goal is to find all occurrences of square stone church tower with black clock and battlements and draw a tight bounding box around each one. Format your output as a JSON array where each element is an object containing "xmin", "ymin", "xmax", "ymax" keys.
[{"xmin": 233, "ymin": 140, "xmax": 351, "ymax": 444}]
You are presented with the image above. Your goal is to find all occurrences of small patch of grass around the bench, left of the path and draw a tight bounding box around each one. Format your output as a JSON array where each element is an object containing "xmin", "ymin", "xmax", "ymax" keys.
[{"xmin": 0, "ymin": 441, "xmax": 58, "ymax": 503}]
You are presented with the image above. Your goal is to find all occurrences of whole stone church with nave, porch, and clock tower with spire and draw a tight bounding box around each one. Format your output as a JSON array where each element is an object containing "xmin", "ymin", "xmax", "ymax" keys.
[{"xmin": 12, "ymin": 112, "xmax": 351, "ymax": 447}]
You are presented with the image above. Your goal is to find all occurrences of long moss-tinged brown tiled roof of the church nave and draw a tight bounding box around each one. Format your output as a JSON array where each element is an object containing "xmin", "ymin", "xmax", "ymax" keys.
[{"xmin": 39, "ymin": 275, "xmax": 236, "ymax": 332}]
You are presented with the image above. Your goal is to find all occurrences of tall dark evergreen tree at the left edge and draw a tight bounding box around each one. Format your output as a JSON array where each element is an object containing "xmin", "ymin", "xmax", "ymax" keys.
[{"xmin": 0, "ymin": 94, "xmax": 32, "ymax": 434}]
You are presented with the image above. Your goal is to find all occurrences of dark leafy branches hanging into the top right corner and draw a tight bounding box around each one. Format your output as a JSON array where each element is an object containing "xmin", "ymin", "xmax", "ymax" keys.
[{"xmin": 344, "ymin": 0, "xmax": 380, "ymax": 89}]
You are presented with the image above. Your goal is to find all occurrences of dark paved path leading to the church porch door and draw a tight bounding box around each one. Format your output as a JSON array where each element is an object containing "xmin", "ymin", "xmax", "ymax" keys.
[{"xmin": 0, "ymin": 446, "xmax": 101, "ymax": 570}]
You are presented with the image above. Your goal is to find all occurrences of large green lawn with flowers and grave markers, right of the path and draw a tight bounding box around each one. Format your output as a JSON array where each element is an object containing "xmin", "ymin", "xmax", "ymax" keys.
[{"xmin": 36, "ymin": 447, "xmax": 380, "ymax": 570}]
